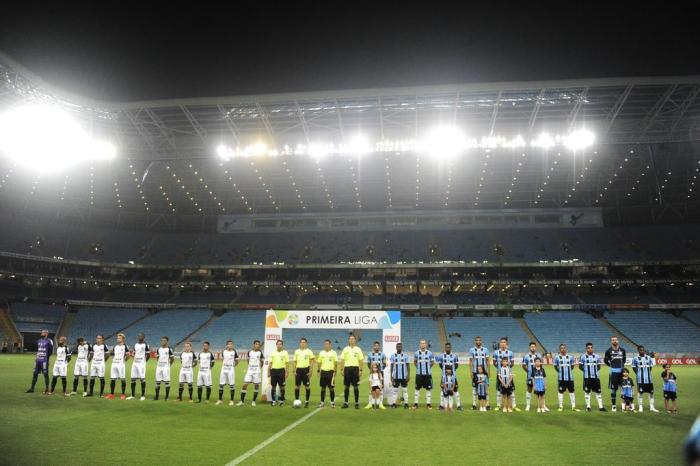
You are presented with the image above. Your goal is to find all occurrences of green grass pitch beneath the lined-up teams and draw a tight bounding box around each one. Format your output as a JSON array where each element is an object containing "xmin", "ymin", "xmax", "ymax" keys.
[{"xmin": 0, "ymin": 355, "xmax": 700, "ymax": 465}]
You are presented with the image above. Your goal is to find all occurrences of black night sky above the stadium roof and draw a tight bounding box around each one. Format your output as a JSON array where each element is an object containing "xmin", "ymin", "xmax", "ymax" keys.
[{"xmin": 0, "ymin": 1, "xmax": 700, "ymax": 100}]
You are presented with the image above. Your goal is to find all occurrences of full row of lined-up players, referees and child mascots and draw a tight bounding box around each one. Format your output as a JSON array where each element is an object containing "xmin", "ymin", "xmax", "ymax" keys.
[{"xmin": 27, "ymin": 331, "xmax": 677, "ymax": 413}]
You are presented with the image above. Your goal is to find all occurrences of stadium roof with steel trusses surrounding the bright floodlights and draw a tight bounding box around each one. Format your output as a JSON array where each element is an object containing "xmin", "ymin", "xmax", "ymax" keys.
[{"xmin": 0, "ymin": 49, "xmax": 700, "ymax": 228}]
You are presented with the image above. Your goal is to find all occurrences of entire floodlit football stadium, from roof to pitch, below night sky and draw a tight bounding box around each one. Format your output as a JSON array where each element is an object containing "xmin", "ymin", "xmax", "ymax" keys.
[{"xmin": 0, "ymin": 10, "xmax": 700, "ymax": 465}]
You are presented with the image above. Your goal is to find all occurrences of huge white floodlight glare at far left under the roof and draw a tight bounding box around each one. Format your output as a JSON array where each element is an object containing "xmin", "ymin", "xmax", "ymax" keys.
[{"xmin": 0, "ymin": 105, "xmax": 117, "ymax": 172}]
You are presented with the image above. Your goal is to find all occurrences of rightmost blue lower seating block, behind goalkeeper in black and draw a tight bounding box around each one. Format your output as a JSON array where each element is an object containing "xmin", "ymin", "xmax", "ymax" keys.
[{"xmin": 605, "ymin": 311, "xmax": 700, "ymax": 353}]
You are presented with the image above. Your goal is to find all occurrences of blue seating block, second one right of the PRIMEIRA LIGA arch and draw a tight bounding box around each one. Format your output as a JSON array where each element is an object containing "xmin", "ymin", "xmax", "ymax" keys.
[{"xmin": 442, "ymin": 317, "xmax": 530, "ymax": 353}]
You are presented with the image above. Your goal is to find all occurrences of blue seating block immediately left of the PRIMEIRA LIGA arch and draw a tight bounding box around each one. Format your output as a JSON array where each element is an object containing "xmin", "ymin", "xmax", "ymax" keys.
[{"xmin": 183, "ymin": 311, "xmax": 265, "ymax": 351}]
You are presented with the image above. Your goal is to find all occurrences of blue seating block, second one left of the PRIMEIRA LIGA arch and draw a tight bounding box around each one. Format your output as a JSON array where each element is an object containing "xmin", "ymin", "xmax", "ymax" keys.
[{"xmin": 107, "ymin": 309, "xmax": 212, "ymax": 346}]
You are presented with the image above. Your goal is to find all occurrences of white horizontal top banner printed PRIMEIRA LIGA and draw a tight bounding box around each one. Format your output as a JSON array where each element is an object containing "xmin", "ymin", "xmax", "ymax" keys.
[{"xmin": 265, "ymin": 310, "xmax": 401, "ymax": 333}]
